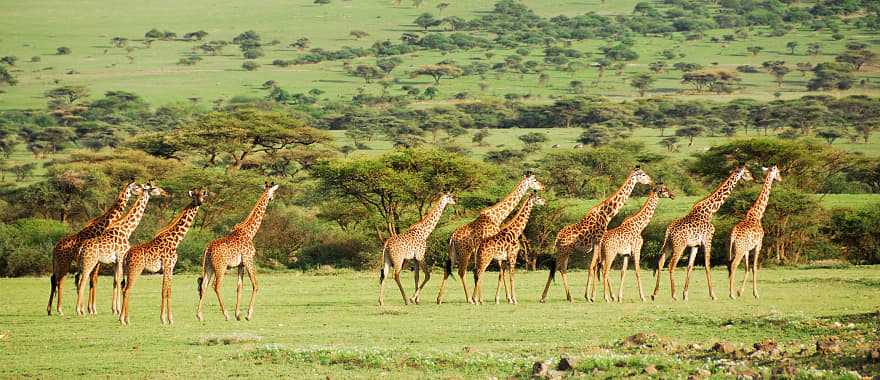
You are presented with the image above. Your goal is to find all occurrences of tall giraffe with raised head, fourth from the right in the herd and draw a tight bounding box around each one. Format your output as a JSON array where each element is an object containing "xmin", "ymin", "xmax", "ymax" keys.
[{"xmin": 541, "ymin": 166, "xmax": 651, "ymax": 303}]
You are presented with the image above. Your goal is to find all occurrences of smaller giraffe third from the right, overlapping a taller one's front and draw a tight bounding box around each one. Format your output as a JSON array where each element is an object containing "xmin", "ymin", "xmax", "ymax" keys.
[{"xmin": 599, "ymin": 183, "xmax": 675, "ymax": 302}]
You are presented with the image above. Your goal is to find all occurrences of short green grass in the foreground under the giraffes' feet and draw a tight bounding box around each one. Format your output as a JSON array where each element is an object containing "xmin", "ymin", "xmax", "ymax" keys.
[{"xmin": 0, "ymin": 267, "xmax": 880, "ymax": 378}]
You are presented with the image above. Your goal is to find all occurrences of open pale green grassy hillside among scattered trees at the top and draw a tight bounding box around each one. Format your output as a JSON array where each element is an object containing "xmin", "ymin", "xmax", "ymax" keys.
[{"xmin": 0, "ymin": 0, "xmax": 880, "ymax": 109}]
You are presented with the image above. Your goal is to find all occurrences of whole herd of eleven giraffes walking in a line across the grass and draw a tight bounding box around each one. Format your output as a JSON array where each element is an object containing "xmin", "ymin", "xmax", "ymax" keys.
[{"xmin": 46, "ymin": 164, "xmax": 782, "ymax": 325}]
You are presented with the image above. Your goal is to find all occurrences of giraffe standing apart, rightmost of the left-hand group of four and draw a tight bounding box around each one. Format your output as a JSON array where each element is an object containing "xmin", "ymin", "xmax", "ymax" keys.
[{"xmin": 196, "ymin": 182, "xmax": 278, "ymax": 321}]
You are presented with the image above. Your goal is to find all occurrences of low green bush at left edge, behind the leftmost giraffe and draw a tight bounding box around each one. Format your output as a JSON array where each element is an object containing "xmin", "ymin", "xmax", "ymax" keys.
[{"xmin": 0, "ymin": 219, "xmax": 68, "ymax": 276}]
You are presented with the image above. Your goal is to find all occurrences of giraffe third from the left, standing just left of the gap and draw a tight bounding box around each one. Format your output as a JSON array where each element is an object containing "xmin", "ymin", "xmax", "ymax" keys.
[{"xmin": 119, "ymin": 189, "xmax": 208, "ymax": 325}]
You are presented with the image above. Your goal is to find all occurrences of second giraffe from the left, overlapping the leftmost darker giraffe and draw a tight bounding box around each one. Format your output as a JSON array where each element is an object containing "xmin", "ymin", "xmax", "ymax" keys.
[{"xmin": 76, "ymin": 183, "xmax": 166, "ymax": 315}]
